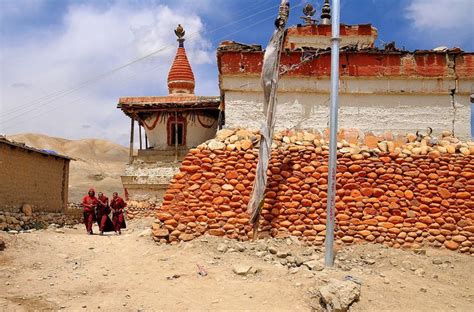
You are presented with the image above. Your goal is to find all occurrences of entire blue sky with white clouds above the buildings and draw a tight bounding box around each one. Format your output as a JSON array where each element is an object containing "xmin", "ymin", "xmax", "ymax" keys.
[{"xmin": 0, "ymin": 0, "xmax": 474, "ymax": 144}]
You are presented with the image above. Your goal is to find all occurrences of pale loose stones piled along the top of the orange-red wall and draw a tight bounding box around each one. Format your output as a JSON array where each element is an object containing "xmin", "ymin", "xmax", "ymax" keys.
[{"xmin": 198, "ymin": 129, "xmax": 474, "ymax": 158}]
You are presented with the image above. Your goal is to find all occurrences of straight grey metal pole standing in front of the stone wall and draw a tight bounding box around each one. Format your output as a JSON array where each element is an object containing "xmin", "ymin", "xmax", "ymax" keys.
[{"xmin": 324, "ymin": 0, "xmax": 341, "ymax": 267}]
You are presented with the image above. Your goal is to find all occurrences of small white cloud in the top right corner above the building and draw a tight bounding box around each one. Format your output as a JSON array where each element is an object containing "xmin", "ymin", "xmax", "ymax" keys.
[{"xmin": 405, "ymin": 0, "xmax": 474, "ymax": 49}]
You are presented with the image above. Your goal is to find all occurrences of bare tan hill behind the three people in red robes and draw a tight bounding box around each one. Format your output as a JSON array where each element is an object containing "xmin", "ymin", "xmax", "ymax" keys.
[{"xmin": 8, "ymin": 133, "xmax": 128, "ymax": 202}]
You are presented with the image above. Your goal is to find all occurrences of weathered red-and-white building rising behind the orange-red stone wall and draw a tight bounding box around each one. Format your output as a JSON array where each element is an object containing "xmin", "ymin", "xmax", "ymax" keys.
[{"xmin": 217, "ymin": 15, "xmax": 474, "ymax": 139}]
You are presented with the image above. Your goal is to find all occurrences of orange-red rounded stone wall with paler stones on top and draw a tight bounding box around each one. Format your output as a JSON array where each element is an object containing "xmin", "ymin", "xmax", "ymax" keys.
[{"xmin": 153, "ymin": 130, "xmax": 474, "ymax": 253}]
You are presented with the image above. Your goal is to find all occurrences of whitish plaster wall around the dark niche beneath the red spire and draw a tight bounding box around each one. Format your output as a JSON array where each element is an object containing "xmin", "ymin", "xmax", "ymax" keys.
[{"xmin": 145, "ymin": 115, "xmax": 217, "ymax": 150}]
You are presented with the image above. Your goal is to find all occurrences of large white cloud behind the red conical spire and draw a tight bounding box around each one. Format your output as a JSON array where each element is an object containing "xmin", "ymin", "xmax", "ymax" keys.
[{"xmin": 0, "ymin": 2, "xmax": 217, "ymax": 143}]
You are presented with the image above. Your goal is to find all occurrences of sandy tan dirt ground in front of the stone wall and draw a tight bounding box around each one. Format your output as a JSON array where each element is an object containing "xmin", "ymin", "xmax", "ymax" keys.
[{"xmin": 0, "ymin": 220, "xmax": 474, "ymax": 311}]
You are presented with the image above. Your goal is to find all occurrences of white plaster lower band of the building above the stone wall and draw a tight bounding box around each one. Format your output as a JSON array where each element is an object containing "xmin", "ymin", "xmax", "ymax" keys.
[{"xmin": 223, "ymin": 78, "xmax": 472, "ymax": 139}]
